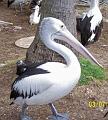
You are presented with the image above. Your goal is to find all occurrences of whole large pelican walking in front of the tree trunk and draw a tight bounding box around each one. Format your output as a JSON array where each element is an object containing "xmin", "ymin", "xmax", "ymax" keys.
[{"xmin": 10, "ymin": 17, "xmax": 101, "ymax": 120}]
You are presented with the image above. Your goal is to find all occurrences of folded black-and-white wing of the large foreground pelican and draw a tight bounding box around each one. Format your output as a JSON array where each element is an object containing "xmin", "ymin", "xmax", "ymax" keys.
[{"xmin": 10, "ymin": 68, "xmax": 53, "ymax": 100}]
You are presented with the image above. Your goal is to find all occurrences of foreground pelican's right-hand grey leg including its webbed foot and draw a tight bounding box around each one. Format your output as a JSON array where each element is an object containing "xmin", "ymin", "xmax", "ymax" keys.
[{"xmin": 49, "ymin": 103, "xmax": 69, "ymax": 120}]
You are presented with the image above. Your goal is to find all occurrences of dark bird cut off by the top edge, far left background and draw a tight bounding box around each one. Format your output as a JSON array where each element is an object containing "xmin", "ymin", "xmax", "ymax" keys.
[{"xmin": 7, "ymin": 0, "xmax": 31, "ymax": 12}]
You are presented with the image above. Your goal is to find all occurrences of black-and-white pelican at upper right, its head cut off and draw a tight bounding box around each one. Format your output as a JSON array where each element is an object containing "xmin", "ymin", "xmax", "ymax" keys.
[{"xmin": 80, "ymin": 0, "xmax": 103, "ymax": 46}]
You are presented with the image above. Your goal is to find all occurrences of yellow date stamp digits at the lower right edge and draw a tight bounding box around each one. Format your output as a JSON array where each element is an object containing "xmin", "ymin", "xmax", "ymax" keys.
[{"xmin": 88, "ymin": 101, "xmax": 108, "ymax": 108}]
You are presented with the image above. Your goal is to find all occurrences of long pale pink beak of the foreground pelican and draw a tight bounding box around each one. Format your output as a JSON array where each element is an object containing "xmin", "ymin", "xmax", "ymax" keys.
[{"xmin": 55, "ymin": 29, "xmax": 103, "ymax": 68}]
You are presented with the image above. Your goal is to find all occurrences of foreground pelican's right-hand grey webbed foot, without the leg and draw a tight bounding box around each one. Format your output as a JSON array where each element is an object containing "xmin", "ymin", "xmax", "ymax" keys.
[{"xmin": 48, "ymin": 113, "xmax": 69, "ymax": 120}]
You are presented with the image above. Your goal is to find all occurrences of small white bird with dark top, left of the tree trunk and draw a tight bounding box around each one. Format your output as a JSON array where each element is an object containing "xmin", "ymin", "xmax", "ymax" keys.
[{"xmin": 29, "ymin": 0, "xmax": 42, "ymax": 25}]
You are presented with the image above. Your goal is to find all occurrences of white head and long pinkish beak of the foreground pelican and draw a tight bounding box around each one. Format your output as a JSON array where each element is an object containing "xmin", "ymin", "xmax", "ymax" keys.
[{"xmin": 39, "ymin": 17, "xmax": 102, "ymax": 67}]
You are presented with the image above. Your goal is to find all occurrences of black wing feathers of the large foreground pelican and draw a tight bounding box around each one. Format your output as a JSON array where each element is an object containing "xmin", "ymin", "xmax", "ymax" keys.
[{"xmin": 10, "ymin": 63, "xmax": 50, "ymax": 100}]
